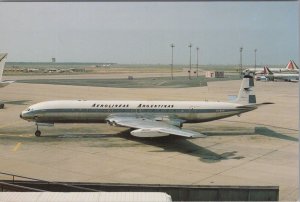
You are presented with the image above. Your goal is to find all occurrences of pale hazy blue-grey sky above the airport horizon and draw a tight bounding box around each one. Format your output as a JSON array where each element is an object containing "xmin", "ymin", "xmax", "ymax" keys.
[{"xmin": 0, "ymin": 1, "xmax": 299, "ymax": 65}]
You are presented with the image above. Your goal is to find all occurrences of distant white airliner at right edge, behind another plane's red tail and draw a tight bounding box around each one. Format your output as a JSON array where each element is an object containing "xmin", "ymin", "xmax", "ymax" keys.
[{"xmin": 243, "ymin": 60, "xmax": 299, "ymax": 75}]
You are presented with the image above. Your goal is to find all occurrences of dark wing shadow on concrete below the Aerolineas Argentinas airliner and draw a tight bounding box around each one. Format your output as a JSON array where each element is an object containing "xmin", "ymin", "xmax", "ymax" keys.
[{"xmin": 118, "ymin": 131, "xmax": 244, "ymax": 163}]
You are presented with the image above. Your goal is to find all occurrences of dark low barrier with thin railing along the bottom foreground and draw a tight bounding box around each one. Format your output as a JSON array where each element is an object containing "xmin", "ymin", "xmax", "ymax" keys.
[{"xmin": 0, "ymin": 172, "xmax": 279, "ymax": 201}]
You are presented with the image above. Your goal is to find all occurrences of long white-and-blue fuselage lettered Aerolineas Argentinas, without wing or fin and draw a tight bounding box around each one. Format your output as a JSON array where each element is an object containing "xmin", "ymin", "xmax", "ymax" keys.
[{"xmin": 21, "ymin": 100, "xmax": 256, "ymax": 124}]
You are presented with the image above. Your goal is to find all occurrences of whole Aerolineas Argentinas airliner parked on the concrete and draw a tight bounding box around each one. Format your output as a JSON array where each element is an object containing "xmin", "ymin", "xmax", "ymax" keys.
[{"xmin": 20, "ymin": 75, "xmax": 272, "ymax": 137}]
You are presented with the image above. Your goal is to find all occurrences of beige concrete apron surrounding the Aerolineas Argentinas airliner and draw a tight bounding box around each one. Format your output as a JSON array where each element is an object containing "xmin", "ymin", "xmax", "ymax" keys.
[{"xmin": 0, "ymin": 77, "xmax": 299, "ymax": 201}]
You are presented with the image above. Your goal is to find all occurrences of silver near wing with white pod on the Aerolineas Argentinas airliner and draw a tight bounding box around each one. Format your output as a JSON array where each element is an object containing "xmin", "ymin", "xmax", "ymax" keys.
[{"xmin": 106, "ymin": 116, "xmax": 206, "ymax": 137}]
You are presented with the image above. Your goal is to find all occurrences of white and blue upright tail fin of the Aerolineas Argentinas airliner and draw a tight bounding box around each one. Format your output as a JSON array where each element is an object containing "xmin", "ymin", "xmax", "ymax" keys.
[{"xmin": 234, "ymin": 75, "xmax": 256, "ymax": 105}]
